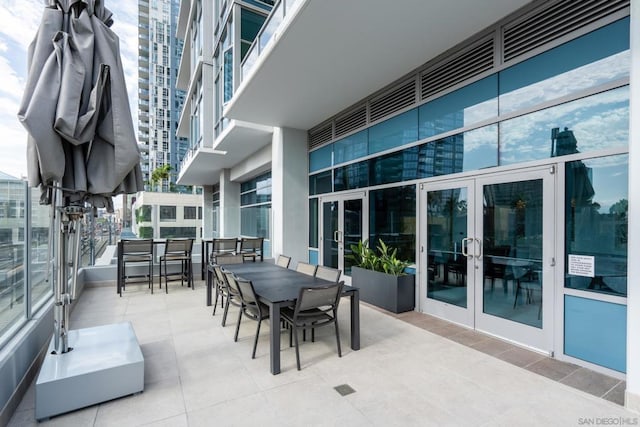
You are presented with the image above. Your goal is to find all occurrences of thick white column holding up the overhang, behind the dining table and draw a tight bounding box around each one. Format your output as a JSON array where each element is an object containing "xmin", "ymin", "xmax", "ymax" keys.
[{"xmin": 271, "ymin": 128, "xmax": 309, "ymax": 266}]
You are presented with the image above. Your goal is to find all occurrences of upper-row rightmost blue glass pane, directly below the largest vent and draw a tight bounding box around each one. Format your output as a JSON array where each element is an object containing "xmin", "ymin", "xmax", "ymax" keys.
[{"xmin": 500, "ymin": 18, "xmax": 630, "ymax": 114}]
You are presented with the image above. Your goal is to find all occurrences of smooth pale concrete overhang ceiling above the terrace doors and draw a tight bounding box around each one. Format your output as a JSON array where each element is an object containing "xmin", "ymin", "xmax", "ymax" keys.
[{"xmin": 225, "ymin": 0, "xmax": 529, "ymax": 130}]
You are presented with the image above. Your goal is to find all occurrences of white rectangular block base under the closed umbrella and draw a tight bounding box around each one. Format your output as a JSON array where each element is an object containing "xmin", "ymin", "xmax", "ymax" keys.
[{"xmin": 36, "ymin": 322, "xmax": 144, "ymax": 420}]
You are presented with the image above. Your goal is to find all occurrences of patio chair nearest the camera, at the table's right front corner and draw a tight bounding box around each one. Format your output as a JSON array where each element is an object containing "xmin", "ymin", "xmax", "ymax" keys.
[{"xmin": 281, "ymin": 283, "xmax": 342, "ymax": 370}]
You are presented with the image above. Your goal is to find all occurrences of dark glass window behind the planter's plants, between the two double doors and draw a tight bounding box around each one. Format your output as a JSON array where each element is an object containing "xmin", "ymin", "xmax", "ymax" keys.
[{"xmin": 369, "ymin": 185, "xmax": 416, "ymax": 262}]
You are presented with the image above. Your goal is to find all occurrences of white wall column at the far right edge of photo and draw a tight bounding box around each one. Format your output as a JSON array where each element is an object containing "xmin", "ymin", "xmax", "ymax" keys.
[{"xmin": 625, "ymin": 1, "xmax": 640, "ymax": 412}]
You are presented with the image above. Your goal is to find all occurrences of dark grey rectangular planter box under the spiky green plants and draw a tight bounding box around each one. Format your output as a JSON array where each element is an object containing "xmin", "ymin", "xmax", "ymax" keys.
[{"xmin": 351, "ymin": 267, "xmax": 416, "ymax": 313}]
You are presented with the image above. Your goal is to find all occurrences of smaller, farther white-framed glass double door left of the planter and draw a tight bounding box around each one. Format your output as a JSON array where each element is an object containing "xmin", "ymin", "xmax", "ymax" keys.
[{"xmin": 319, "ymin": 193, "xmax": 369, "ymax": 284}]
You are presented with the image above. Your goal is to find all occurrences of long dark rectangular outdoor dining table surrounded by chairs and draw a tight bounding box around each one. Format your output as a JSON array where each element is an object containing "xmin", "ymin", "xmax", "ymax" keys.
[{"xmin": 224, "ymin": 262, "xmax": 360, "ymax": 375}]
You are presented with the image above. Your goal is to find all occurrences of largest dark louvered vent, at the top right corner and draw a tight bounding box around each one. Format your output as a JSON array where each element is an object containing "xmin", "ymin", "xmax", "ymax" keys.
[{"xmin": 503, "ymin": 0, "xmax": 629, "ymax": 63}]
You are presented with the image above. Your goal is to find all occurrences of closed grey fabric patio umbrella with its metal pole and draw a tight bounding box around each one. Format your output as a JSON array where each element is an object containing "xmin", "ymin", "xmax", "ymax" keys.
[{"xmin": 18, "ymin": 0, "xmax": 143, "ymax": 353}]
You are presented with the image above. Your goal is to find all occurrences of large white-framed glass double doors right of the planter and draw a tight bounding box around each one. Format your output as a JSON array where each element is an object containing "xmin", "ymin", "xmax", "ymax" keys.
[{"xmin": 420, "ymin": 168, "xmax": 555, "ymax": 351}]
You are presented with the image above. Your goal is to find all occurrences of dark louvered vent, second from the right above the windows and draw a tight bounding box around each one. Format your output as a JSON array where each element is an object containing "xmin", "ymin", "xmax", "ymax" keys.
[{"xmin": 420, "ymin": 37, "xmax": 494, "ymax": 99}]
